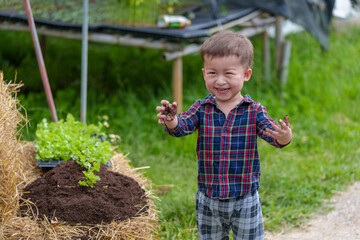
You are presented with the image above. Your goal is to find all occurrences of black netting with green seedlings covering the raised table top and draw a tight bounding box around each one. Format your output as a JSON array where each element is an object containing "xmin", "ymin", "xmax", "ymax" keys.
[{"xmin": 0, "ymin": 0, "xmax": 335, "ymax": 48}]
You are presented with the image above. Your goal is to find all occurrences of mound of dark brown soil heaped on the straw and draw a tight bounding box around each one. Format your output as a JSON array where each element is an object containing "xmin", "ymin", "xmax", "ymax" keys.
[{"xmin": 21, "ymin": 161, "xmax": 147, "ymax": 224}]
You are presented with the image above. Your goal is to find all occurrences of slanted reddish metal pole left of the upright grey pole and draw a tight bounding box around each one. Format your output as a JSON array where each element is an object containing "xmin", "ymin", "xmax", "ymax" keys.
[{"xmin": 24, "ymin": 0, "xmax": 58, "ymax": 123}]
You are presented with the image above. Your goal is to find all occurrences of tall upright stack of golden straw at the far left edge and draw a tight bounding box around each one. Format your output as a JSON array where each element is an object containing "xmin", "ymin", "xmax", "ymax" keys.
[{"xmin": 0, "ymin": 71, "xmax": 26, "ymax": 232}]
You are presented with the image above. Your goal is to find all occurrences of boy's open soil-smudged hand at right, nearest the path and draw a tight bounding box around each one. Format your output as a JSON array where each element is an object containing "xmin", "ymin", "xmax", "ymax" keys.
[{"xmin": 264, "ymin": 115, "xmax": 292, "ymax": 145}]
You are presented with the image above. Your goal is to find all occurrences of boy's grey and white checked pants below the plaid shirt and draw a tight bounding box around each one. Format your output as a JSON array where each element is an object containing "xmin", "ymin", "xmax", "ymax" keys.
[{"xmin": 196, "ymin": 191, "xmax": 265, "ymax": 240}]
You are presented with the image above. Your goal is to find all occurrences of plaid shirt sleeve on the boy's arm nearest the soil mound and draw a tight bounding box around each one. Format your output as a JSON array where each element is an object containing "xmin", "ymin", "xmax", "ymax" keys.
[{"xmin": 165, "ymin": 101, "xmax": 201, "ymax": 137}]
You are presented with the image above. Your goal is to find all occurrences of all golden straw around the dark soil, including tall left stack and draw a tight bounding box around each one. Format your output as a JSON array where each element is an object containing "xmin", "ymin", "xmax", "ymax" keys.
[{"xmin": 0, "ymin": 74, "xmax": 158, "ymax": 240}]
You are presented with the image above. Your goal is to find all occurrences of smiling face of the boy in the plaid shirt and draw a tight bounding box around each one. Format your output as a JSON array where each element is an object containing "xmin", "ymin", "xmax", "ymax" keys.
[{"xmin": 202, "ymin": 56, "xmax": 252, "ymax": 104}]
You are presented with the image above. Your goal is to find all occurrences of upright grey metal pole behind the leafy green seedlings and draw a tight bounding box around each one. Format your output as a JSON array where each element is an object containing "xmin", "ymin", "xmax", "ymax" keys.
[{"xmin": 80, "ymin": 0, "xmax": 89, "ymax": 122}]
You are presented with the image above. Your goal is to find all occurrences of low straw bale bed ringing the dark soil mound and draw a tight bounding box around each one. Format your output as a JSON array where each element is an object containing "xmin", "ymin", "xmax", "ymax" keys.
[{"xmin": 4, "ymin": 142, "xmax": 158, "ymax": 239}]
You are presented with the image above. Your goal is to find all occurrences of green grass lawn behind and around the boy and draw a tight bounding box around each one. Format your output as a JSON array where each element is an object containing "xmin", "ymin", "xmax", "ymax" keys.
[{"xmin": 0, "ymin": 21, "xmax": 360, "ymax": 239}]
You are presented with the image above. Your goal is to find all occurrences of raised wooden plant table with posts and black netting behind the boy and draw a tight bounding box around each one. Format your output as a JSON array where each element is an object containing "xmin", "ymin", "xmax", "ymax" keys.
[{"xmin": 0, "ymin": 0, "xmax": 335, "ymax": 119}]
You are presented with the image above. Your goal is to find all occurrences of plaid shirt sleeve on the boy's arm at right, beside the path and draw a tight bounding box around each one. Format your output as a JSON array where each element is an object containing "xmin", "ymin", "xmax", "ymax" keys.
[{"xmin": 256, "ymin": 103, "xmax": 290, "ymax": 148}]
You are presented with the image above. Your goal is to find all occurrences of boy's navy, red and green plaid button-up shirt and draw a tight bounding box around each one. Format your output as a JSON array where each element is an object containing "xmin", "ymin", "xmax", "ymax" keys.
[{"xmin": 165, "ymin": 94, "xmax": 284, "ymax": 199}]
